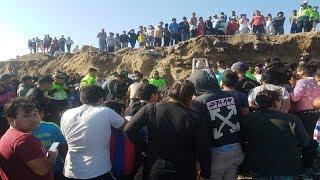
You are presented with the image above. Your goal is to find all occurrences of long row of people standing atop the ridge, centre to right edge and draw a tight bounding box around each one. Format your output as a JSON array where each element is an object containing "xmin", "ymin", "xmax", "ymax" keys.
[{"xmin": 97, "ymin": 2, "xmax": 319, "ymax": 53}]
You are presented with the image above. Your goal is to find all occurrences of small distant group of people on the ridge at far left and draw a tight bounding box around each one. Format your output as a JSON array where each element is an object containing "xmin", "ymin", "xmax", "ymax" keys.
[{"xmin": 28, "ymin": 34, "xmax": 79, "ymax": 56}]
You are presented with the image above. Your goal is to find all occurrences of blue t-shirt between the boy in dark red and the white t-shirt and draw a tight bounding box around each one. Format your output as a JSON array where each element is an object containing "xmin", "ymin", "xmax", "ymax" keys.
[{"xmin": 32, "ymin": 121, "xmax": 67, "ymax": 173}]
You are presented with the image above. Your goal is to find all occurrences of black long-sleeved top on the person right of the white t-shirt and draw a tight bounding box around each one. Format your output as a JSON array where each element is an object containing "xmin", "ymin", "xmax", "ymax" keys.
[{"xmin": 124, "ymin": 102, "xmax": 211, "ymax": 178}]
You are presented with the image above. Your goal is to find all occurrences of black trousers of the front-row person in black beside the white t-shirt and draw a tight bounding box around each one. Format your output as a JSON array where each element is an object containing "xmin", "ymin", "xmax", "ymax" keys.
[{"xmin": 149, "ymin": 159, "xmax": 196, "ymax": 180}]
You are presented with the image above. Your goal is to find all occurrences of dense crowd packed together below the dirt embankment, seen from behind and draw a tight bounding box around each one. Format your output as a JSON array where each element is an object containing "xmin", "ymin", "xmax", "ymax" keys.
[{"xmin": 0, "ymin": 54, "xmax": 320, "ymax": 180}]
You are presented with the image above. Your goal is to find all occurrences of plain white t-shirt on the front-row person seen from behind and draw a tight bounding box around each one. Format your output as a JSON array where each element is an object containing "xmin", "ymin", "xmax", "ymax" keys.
[{"xmin": 61, "ymin": 105, "xmax": 124, "ymax": 179}]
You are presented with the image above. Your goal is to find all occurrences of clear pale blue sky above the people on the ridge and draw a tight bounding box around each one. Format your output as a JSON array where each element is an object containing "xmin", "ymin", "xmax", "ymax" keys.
[{"xmin": 0, "ymin": 0, "xmax": 320, "ymax": 60}]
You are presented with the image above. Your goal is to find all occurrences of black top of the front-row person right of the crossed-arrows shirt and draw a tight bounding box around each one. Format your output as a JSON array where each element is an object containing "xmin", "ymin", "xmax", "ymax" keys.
[{"xmin": 241, "ymin": 110, "xmax": 309, "ymax": 176}]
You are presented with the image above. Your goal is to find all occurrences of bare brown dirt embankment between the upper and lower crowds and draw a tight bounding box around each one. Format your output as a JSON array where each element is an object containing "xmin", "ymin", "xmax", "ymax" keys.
[{"xmin": 0, "ymin": 32, "xmax": 320, "ymax": 81}]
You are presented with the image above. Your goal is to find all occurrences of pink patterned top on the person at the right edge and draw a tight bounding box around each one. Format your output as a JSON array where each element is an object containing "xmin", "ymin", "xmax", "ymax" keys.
[{"xmin": 291, "ymin": 77, "xmax": 320, "ymax": 112}]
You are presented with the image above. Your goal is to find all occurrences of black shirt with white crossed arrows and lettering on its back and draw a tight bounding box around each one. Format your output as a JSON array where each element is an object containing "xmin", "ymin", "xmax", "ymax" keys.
[{"xmin": 194, "ymin": 90, "xmax": 241, "ymax": 147}]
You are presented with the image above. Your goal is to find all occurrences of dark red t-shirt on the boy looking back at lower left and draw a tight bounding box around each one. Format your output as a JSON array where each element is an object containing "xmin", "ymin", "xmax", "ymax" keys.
[{"xmin": 0, "ymin": 129, "xmax": 53, "ymax": 180}]
